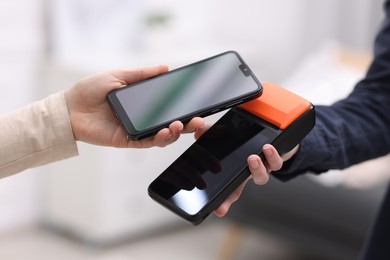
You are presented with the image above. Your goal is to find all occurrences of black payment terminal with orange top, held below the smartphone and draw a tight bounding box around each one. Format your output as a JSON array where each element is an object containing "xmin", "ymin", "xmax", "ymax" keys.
[{"xmin": 148, "ymin": 83, "xmax": 315, "ymax": 225}]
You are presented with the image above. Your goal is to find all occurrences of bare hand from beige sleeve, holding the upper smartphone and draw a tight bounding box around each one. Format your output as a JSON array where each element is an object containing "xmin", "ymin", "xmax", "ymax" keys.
[{"xmin": 64, "ymin": 65, "xmax": 204, "ymax": 148}]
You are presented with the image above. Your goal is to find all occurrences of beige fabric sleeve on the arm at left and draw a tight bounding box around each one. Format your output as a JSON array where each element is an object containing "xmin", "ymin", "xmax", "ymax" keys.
[{"xmin": 0, "ymin": 92, "xmax": 78, "ymax": 178}]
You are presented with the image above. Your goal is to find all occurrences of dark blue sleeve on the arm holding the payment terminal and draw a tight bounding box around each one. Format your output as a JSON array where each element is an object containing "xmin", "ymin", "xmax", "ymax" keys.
[{"xmin": 274, "ymin": 1, "xmax": 390, "ymax": 180}]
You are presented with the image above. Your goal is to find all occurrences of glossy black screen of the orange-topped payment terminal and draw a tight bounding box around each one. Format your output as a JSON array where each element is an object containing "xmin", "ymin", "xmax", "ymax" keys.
[{"xmin": 149, "ymin": 109, "xmax": 277, "ymax": 218}]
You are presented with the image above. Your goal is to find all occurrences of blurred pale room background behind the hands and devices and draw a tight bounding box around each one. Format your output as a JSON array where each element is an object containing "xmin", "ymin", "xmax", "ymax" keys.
[{"xmin": 0, "ymin": 0, "xmax": 390, "ymax": 260}]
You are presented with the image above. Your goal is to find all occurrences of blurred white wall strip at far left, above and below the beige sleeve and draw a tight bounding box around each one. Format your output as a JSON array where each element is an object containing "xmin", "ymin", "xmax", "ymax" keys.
[{"xmin": 0, "ymin": 0, "xmax": 44, "ymax": 232}]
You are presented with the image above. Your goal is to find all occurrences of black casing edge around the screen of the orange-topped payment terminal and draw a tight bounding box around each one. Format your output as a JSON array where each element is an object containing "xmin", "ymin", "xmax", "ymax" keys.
[{"xmin": 148, "ymin": 106, "xmax": 315, "ymax": 225}]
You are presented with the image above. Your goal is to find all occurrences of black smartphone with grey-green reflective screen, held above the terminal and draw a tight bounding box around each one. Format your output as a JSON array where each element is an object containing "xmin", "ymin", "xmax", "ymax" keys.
[{"xmin": 107, "ymin": 51, "xmax": 262, "ymax": 140}]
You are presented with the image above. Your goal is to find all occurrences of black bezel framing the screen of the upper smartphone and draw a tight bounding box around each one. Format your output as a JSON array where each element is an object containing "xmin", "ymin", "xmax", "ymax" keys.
[{"xmin": 107, "ymin": 50, "xmax": 263, "ymax": 140}]
